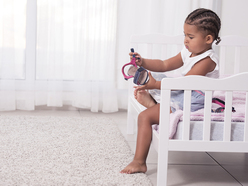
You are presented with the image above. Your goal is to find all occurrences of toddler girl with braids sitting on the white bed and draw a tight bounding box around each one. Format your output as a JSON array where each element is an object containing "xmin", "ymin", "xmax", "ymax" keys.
[{"xmin": 121, "ymin": 8, "xmax": 221, "ymax": 174}]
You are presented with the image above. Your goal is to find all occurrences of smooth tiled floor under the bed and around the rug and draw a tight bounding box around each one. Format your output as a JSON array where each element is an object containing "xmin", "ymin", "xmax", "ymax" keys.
[{"xmin": 0, "ymin": 107, "xmax": 248, "ymax": 186}]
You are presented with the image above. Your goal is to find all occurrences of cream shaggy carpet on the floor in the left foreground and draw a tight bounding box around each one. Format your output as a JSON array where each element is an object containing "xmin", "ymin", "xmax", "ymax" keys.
[{"xmin": 0, "ymin": 116, "xmax": 152, "ymax": 186}]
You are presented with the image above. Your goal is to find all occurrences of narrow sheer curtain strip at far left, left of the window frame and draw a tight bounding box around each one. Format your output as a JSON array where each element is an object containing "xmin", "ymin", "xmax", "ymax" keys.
[{"xmin": 0, "ymin": 0, "xmax": 26, "ymax": 111}]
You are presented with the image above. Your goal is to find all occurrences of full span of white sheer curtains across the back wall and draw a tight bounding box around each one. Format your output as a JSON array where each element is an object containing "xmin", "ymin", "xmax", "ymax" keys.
[{"xmin": 0, "ymin": 0, "xmax": 221, "ymax": 112}]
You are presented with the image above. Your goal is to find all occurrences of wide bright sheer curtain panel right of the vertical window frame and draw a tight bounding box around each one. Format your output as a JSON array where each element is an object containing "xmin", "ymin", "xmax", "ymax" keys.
[{"xmin": 36, "ymin": 0, "xmax": 118, "ymax": 112}]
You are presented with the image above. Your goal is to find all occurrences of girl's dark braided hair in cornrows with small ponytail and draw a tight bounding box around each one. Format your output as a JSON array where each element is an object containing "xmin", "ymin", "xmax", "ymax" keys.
[{"xmin": 185, "ymin": 8, "xmax": 221, "ymax": 45}]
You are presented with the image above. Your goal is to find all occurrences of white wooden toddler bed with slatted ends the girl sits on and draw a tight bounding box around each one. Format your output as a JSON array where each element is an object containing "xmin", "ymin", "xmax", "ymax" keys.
[{"xmin": 127, "ymin": 34, "xmax": 248, "ymax": 186}]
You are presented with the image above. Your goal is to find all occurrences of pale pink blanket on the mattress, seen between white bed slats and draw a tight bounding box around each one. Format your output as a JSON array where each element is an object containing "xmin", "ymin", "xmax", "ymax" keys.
[{"xmin": 153, "ymin": 91, "xmax": 246, "ymax": 139}]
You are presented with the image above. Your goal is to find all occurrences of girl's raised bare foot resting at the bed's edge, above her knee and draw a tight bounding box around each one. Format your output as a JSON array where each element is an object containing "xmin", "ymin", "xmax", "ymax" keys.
[{"xmin": 134, "ymin": 89, "xmax": 156, "ymax": 108}]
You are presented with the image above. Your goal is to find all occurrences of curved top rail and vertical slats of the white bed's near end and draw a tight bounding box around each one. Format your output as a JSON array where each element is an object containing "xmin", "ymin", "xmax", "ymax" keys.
[{"xmin": 160, "ymin": 72, "xmax": 248, "ymax": 141}]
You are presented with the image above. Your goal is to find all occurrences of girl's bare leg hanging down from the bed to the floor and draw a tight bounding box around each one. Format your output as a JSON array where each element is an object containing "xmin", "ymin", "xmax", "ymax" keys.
[{"xmin": 121, "ymin": 104, "xmax": 160, "ymax": 174}]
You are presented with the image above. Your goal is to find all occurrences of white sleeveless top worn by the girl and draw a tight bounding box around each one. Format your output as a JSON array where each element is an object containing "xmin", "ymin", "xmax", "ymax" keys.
[{"xmin": 181, "ymin": 46, "xmax": 219, "ymax": 78}]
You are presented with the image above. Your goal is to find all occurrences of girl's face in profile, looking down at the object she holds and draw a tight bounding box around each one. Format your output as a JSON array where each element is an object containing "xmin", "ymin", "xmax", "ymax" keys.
[{"xmin": 184, "ymin": 23, "xmax": 212, "ymax": 57}]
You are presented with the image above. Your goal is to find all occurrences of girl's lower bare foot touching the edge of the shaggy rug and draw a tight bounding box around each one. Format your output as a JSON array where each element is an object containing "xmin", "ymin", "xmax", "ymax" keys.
[{"xmin": 120, "ymin": 160, "xmax": 147, "ymax": 174}]
